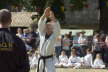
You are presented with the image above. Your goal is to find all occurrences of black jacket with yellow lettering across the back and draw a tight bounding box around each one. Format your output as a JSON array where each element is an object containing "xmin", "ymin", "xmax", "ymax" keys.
[{"xmin": 0, "ymin": 28, "xmax": 30, "ymax": 72}]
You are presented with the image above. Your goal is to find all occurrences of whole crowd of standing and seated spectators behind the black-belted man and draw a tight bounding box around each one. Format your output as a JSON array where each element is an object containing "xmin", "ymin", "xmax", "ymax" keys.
[{"xmin": 16, "ymin": 28, "xmax": 108, "ymax": 69}]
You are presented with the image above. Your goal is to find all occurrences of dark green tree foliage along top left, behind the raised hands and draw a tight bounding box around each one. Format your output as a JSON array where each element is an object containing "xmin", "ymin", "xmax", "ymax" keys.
[{"xmin": 0, "ymin": 0, "xmax": 64, "ymax": 19}]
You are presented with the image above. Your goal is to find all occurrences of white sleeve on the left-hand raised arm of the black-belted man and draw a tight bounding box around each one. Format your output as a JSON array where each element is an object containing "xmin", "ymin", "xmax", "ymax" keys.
[{"xmin": 38, "ymin": 16, "xmax": 47, "ymax": 35}]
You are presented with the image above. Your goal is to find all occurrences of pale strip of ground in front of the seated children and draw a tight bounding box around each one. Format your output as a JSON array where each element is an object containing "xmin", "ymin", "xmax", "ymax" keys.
[{"xmin": 31, "ymin": 68, "xmax": 108, "ymax": 72}]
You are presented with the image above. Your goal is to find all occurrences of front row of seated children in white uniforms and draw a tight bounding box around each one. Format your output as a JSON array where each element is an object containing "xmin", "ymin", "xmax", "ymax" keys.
[{"xmin": 28, "ymin": 48, "xmax": 106, "ymax": 69}]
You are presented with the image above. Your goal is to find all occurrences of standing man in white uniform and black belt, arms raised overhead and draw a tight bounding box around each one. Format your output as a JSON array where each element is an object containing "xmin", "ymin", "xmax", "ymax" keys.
[{"xmin": 37, "ymin": 7, "xmax": 60, "ymax": 72}]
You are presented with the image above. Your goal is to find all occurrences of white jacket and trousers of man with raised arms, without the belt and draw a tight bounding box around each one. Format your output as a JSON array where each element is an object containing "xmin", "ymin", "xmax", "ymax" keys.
[{"xmin": 38, "ymin": 16, "xmax": 60, "ymax": 72}]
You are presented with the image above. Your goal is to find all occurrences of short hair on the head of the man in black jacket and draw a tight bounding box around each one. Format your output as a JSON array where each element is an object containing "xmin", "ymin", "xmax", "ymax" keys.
[{"xmin": 0, "ymin": 9, "xmax": 12, "ymax": 24}]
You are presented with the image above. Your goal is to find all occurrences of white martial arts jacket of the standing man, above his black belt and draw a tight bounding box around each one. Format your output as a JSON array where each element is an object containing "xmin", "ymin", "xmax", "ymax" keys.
[{"xmin": 38, "ymin": 17, "xmax": 60, "ymax": 56}]
